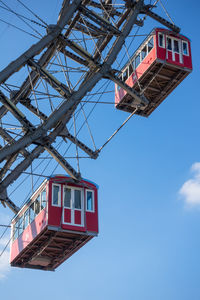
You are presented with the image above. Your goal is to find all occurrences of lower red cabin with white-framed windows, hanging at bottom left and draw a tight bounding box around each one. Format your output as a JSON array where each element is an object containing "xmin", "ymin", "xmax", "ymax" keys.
[{"xmin": 10, "ymin": 175, "xmax": 98, "ymax": 270}]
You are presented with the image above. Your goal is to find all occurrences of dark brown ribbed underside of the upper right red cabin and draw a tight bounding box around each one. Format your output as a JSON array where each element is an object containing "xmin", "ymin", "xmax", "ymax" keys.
[{"xmin": 116, "ymin": 60, "xmax": 191, "ymax": 117}]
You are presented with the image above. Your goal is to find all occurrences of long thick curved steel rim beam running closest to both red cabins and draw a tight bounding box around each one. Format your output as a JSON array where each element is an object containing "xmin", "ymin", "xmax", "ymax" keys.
[{"xmin": 0, "ymin": 0, "xmax": 143, "ymax": 161}]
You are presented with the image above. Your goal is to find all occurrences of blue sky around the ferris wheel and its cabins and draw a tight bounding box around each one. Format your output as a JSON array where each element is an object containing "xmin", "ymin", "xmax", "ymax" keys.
[{"xmin": 0, "ymin": 0, "xmax": 200, "ymax": 300}]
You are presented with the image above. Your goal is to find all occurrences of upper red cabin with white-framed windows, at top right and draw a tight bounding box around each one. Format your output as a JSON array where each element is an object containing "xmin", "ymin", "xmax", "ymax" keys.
[{"xmin": 115, "ymin": 28, "xmax": 192, "ymax": 117}]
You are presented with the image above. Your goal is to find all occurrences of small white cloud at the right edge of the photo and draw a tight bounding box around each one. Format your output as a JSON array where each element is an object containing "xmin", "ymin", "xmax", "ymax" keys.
[{"xmin": 179, "ymin": 162, "xmax": 200, "ymax": 207}]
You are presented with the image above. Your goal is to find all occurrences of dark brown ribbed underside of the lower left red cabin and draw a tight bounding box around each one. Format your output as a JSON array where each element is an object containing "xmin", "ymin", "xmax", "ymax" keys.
[{"xmin": 11, "ymin": 226, "xmax": 96, "ymax": 271}]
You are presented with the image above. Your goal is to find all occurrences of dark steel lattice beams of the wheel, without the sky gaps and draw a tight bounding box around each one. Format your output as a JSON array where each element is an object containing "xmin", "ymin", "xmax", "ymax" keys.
[{"xmin": 0, "ymin": 0, "xmax": 181, "ymax": 213}]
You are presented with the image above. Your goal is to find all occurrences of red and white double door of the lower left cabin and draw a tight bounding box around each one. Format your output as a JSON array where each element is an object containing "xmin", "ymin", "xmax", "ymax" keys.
[{"xmin": 63, "ymin": 186, "xmax": 84, "ymax": 226}]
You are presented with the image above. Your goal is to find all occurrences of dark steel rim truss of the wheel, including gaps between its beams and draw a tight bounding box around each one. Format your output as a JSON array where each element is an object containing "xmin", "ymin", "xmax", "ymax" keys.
[{"xmin": 0, "ymin": 0, "xmax": 180, "ymax": 213}]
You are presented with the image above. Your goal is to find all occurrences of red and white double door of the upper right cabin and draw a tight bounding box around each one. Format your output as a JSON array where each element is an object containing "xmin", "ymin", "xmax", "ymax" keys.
[{"xmin": 167, "ymin": 37, "xmax": 183, "ymax": 64}]
